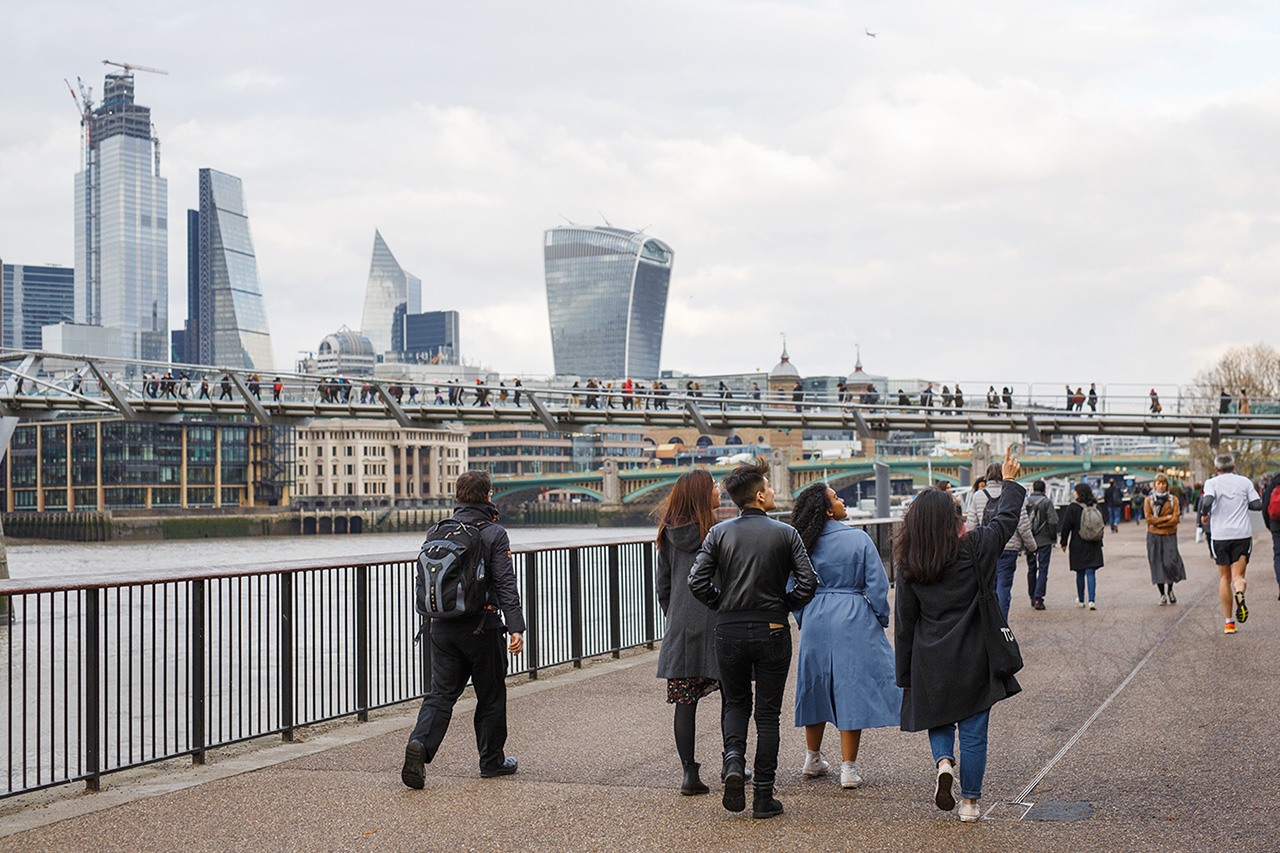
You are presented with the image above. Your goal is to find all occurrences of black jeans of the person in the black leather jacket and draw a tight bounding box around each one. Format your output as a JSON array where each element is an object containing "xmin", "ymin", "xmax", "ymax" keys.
[{"xmin": 716, "ymin": 622, "xmax": 791, "ymax": 790}]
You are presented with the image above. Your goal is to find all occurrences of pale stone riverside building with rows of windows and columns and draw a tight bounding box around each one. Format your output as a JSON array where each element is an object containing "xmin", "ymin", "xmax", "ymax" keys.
[{"xmin": 294, "ymin": 419, "xmax": 467, "ymax": 510}]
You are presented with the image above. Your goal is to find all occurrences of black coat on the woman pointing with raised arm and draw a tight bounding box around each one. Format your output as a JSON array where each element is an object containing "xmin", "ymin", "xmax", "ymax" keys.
[{"xmin": 893, "ymin": 480, "xmax": 1027, "ymax": 731}]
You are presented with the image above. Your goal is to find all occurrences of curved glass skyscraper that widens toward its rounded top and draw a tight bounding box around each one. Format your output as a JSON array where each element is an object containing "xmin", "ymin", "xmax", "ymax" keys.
[{"xmin": 543, "ymin": 227, "xmax": 675, "ymax": 379}]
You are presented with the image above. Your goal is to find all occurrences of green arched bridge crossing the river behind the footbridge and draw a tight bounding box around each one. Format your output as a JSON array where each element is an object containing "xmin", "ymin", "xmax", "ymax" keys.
[{"xmin": 494, "ymin": 453, "xmax": 1187, "ymax": 505}]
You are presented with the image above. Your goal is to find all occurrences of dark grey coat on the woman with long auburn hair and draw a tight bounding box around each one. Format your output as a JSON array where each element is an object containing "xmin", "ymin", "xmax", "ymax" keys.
[{"xmin": 655, "ymin": 524, "xmax": 719, "ymax": 681}]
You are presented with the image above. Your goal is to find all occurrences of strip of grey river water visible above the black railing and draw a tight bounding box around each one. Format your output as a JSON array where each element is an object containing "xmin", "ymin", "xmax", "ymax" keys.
[{"xmin": 9, "ymin": 526, "xmax": 655, "ymax": 578}]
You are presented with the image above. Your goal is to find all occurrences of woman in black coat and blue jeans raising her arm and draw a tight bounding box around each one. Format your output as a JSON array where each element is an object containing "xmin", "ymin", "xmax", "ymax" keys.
[{"xmin": 893, "ymin": 453, "xmax": 1027, "ymax": 822}]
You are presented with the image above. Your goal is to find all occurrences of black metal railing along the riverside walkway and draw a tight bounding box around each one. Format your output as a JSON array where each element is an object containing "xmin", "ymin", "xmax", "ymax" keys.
[{"xmin": 0, "ymin": 521, "xmax": 893, "ymax": 798}]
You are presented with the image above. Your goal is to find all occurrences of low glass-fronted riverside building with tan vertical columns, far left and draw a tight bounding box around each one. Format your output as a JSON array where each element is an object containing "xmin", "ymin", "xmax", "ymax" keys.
[{"xmin": 0, "ymin": 419, "xmax": 294, "ymax": 512}]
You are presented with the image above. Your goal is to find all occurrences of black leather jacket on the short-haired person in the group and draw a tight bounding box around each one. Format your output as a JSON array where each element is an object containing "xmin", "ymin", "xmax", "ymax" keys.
[{"xmin": 689, "ymin": 508, "xmax": 818, "ymax": 624}]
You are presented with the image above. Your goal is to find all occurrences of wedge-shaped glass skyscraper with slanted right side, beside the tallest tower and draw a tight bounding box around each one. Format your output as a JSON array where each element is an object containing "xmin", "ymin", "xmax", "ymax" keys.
[{"xmin": 183, "ymin": 169, "xmax": 274, "ymax": 370}]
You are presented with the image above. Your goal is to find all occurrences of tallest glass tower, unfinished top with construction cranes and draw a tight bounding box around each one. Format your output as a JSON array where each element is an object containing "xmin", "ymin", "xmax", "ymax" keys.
[{"xmin": 76, "ymin": 72, "xmax": 169, "ymax": 360}]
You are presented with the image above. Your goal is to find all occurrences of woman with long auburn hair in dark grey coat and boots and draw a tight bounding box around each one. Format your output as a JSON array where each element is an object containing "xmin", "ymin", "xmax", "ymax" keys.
[{"xmin": 657, "ymin": 469, "xmax": 719, "ymax": 795}]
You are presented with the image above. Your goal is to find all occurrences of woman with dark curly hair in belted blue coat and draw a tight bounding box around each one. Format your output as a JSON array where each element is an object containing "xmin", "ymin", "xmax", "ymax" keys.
[{"xmin": 791, "ymin": 483, "xmax": 902, "ymax": 788}]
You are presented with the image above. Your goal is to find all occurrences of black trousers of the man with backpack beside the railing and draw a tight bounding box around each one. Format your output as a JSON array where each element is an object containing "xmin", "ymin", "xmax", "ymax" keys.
[{"xmin": 410, "ymin": 630, "xmax": 507, "ymax": 772}]
